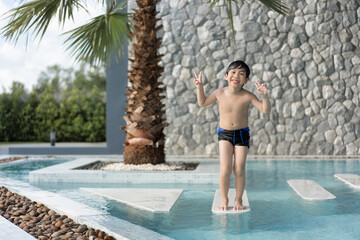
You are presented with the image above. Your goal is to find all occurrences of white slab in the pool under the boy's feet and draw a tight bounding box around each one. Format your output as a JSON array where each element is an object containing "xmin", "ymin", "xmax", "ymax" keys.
[{"xmin": 211, "ymin": 188, "xmax": 250, "ymax": 214}]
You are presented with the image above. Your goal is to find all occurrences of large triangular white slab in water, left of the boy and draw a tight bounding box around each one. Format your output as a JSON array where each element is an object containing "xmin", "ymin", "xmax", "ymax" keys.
[{"xmin": 80, "ymin": 188, "xmax": 183, "ymax": 212}]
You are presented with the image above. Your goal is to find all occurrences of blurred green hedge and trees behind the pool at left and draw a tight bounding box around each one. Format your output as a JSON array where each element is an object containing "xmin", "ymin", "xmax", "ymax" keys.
[{"xmin": 0, "ymin": 65, "xmax": 106, "ymax": 142}]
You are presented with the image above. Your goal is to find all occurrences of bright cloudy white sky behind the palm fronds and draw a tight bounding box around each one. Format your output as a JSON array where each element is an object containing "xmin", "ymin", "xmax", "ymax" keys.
[{"xmin": 0, "ymin": 0, "xmax": 103, "ymax": 93}]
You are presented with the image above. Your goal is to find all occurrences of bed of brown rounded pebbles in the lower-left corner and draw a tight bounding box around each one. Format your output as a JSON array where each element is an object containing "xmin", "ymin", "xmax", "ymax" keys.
[{"xmin": 0, "ymin": 187, "xmax": 115, "ymax": 240}]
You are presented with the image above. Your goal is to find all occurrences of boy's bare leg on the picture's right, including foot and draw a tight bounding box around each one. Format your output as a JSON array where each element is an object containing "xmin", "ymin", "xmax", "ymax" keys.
[{"xmin": 234, "ymin": 146, "xmax": 248, "ymax": 210}]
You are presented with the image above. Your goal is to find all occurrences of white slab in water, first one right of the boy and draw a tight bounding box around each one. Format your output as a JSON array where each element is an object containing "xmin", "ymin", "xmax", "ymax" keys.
[{"xmin": 287, "ymin": 179, "xmax": 336, "ymax": 200}]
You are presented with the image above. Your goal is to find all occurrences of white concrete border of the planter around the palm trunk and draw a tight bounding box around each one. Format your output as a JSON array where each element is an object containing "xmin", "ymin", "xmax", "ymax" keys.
[{"xmin": 29, "ymin": 157, "xmax": 219, "ymax": 184}]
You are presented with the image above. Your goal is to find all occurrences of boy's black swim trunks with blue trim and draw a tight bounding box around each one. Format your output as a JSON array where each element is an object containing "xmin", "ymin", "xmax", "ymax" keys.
[{"xmin": 217, "ymin": 127, "xmax": 250, "ymax": 148}]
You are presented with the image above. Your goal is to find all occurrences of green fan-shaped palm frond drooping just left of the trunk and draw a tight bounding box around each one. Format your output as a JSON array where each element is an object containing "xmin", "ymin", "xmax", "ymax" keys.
[{"xmin": 64, "ymin": 2, "xmax": 131, "ymax": 66}]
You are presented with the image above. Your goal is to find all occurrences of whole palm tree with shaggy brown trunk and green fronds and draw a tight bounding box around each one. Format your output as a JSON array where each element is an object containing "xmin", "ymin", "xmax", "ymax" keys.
[{"xmin": 1, "ymin": 0, "xmax": 288, "ymax": 164}]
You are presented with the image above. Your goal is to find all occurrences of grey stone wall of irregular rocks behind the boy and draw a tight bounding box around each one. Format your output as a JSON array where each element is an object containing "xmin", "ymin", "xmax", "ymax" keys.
[{"xmin": 141, "ymin": 0, "xmax": 360, "ymax": 155}]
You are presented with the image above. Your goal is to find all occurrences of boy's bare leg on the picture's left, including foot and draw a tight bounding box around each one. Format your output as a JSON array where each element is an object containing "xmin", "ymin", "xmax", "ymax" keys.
[{"xmin": 217, "ymin": 140, "xmax": 234, "ymax": 210}]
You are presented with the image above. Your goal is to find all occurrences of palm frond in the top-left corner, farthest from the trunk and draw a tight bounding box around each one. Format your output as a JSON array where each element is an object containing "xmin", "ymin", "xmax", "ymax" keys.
[{"xmin": 1, "ymin": 0, "xmax": 85, "ymax": 44}]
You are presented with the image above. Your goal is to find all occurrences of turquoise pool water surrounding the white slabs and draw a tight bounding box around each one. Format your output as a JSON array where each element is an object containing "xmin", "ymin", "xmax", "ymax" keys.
[{"xmin": 0, "ymin": 160, "xmax": 360, "ymax": 239}]
